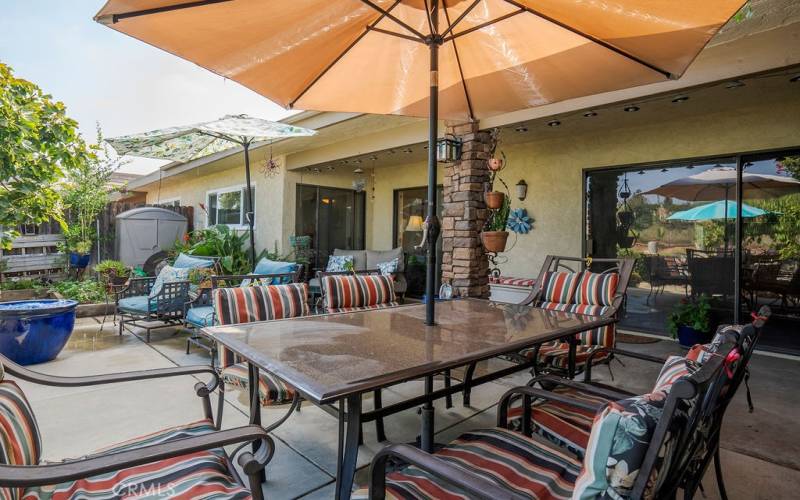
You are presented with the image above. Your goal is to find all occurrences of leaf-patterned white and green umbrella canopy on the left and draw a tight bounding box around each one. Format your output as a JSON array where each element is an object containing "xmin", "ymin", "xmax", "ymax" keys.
[{"xmin": 106, "ymin": 115, "xmax": 316, "ymax": 162}]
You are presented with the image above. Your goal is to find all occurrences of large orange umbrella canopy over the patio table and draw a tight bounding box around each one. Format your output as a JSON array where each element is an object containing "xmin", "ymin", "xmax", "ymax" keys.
[{"xmin": 95, "ymin": 0, "xmax": 744, "ymax": 119}]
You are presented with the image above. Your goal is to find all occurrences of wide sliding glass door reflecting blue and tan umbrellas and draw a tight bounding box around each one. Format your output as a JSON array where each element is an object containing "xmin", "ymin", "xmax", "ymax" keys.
[{"xmin": 584, "ymin": 146, "xmax": 800, "ymax": 352}]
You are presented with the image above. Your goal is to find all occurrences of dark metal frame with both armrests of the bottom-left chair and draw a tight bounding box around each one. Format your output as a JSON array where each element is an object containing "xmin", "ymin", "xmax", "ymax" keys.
[{"xmin": 0, "ymin": 355, "xmax": 275, "ymax": 500}]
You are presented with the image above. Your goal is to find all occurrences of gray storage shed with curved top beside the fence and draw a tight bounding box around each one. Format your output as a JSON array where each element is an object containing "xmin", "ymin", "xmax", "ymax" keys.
[{"xmin": 114, "ymin": 207, "xmax": 188, "ymax": 267}]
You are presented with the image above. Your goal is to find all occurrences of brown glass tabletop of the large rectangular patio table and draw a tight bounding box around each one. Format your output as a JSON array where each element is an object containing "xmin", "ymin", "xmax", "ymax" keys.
[{"xmin": 203, "ymin": 299, "xmax": 615, "ymax": 404}]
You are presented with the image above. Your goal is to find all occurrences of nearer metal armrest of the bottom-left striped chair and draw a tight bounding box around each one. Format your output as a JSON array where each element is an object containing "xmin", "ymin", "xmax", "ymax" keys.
[{"xmin": 0, "ymin": 425, "xmax": 274, "ymax": 487}]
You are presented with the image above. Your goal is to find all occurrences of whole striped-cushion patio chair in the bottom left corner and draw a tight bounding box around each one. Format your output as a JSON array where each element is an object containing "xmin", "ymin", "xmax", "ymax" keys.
[{"xmin": 0, "ymin": 355, "xmax": 275, "ymax": 499}]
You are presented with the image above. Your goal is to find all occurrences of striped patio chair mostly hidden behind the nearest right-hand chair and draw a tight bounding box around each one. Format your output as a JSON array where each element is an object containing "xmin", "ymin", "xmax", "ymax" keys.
[{"xmin": 509, "ymin": 307, "xmax": 771, "ymax": 499}]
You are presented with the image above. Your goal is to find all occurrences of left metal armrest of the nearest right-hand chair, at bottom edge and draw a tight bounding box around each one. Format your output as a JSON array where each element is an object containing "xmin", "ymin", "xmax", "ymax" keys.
[{"xmin": 369, "ymin": 444, "xmax": 526, "ymax": 500}]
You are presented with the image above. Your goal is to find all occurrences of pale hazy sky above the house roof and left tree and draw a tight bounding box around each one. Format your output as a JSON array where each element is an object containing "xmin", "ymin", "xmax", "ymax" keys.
[{"xmin": 0, "ymin": 0, "xmax": 292, "ymax": 173}]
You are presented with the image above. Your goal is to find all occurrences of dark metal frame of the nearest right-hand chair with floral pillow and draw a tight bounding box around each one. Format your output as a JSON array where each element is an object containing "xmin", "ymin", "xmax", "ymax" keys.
[{"xmin": 369, "ymin": 343, "xmax": 734, "ymax": 500}]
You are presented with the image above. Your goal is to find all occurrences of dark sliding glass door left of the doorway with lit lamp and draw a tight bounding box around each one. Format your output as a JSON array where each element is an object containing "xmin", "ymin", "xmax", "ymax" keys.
[{"xmin": 295, "ymin": 184, "xmax": 364, "ymax": 268}]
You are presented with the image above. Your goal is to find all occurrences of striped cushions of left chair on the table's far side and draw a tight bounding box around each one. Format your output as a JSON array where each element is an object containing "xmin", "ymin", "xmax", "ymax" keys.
[{"xmin": 213, "ymin": 283, "xmax": 311, "ymax": 406}]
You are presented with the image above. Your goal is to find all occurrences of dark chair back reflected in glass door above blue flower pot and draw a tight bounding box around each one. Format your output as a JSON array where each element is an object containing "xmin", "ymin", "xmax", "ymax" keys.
[{"xmin": 686, "ymin": 248, "xmax": 734, "ymax": 300}]
